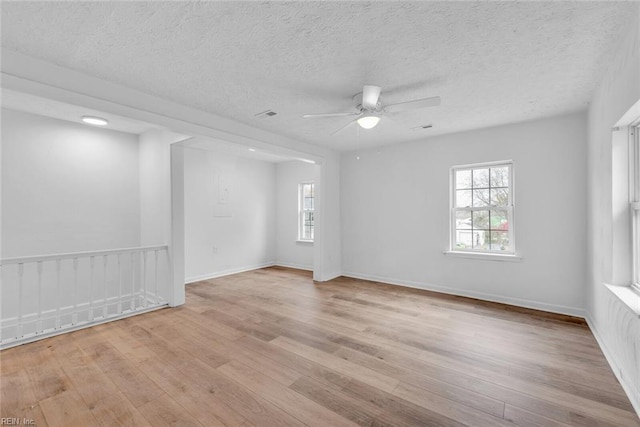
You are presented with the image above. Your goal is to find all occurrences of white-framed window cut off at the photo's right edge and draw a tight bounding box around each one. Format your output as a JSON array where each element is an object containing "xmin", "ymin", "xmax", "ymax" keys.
[{"xmin": 629, "ymin": 124, "xmax": 640, "ymax": 291}]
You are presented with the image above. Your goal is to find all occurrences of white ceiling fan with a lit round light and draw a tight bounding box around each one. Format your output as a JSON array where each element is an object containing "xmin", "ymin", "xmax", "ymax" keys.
[{"xmin": 302, "ymin": 85, "xmax": 440, "ymax": 134}]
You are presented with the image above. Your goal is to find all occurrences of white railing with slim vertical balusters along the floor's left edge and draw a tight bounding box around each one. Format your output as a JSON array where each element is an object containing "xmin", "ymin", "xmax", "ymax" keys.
[{"xmin": 0, "ymin": 245, "xmax": 171, "ymax": 349}]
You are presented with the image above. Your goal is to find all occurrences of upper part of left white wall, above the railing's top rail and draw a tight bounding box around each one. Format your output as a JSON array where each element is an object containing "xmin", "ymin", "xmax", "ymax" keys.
[{"xmin": 2, "ymin": 110, "xmax": 140, "ymax": 258}]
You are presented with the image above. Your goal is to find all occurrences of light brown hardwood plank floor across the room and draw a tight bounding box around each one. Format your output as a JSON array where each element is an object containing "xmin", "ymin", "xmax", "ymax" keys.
[{"xmin": 0, "ymin": 268, "xmax": 640, "ymax": 427}]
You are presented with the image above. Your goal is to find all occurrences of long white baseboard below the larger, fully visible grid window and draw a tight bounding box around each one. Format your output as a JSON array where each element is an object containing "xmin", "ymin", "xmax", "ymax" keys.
[{"xmin": 342, "ymin": 272, "xmax": 585, "ymax": 318}]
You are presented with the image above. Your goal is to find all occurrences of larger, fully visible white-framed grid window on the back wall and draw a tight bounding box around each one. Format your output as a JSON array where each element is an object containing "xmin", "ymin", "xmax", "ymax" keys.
[{"xmin": 451, "ymin": 161, "xmax": 515, "ymax": 254}]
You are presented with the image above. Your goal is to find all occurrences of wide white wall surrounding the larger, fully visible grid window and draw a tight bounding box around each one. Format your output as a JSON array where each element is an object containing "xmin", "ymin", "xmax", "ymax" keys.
[{"xmin": 341, "ymin": 113, "xmax": 587, "ymax": 315}]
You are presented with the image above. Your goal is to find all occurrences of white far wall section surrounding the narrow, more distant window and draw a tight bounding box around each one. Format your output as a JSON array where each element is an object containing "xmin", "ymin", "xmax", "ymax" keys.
[{"xmin": 276, "ymin": 161, "xmax": 320, "ymax": 270}]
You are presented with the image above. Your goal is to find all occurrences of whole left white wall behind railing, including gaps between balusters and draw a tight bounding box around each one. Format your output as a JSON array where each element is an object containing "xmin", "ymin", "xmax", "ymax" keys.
[{"xmin": 0, "ymin": 110, "xmax": 159, "ymax": 339}]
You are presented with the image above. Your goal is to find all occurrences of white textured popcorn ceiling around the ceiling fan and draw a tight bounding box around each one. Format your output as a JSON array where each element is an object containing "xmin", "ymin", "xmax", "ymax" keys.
[{"xmin": 2, "ymin": 1, "xmax": 639, "ymax": 150}]
